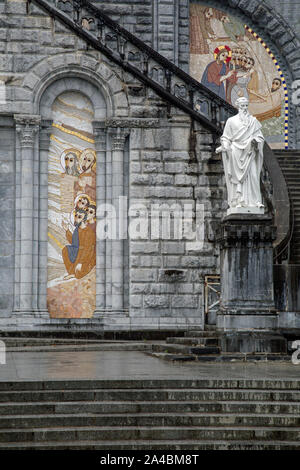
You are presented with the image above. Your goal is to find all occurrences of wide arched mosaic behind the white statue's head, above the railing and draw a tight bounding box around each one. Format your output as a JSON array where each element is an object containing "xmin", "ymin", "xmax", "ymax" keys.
[{"xmin": 190, "ymin": 2, "xmax": 288, "ymax": 149}]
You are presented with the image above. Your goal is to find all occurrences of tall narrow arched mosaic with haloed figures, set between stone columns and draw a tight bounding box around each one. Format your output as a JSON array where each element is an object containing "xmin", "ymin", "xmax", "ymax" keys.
[{"xmin": 47, "ymin": 91, "xmax": 96, "ymax": 318}]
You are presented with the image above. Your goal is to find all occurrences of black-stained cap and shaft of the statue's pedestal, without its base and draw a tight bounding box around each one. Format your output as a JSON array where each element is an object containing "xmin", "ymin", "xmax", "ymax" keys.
[{"xmin": 218, "ymin": 214, "xmax": 276, "ymax": 314}]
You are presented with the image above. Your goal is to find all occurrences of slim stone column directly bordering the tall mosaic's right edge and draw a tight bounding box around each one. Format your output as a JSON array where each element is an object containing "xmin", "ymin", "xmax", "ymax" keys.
[{"xmin": 93, "ymin": 121, "xmax": 107, "ymax": 318}]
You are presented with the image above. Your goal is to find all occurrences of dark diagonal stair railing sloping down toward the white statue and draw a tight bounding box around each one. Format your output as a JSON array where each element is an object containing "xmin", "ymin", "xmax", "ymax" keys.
[{"xmin": 28, "ymin": 0, "xmax": 236, "ymax": 135}]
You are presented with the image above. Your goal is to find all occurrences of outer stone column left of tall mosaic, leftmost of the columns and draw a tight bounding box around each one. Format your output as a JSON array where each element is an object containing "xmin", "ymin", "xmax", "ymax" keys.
[{"xmin": 14, "ymin": 115, "xmax": 40, "ymax": 314}]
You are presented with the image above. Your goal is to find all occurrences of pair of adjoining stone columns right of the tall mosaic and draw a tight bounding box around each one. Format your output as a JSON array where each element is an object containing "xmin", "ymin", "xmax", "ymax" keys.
[{"xmin": 93, "ymin": 125, "xmax": 130, "ymax": 318}]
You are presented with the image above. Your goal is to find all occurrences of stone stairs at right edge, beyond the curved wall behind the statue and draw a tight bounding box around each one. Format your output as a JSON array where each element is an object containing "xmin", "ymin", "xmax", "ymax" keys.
[{"xmin": 274, "ymin": 150, "xmax": 300, "ymax": 264}]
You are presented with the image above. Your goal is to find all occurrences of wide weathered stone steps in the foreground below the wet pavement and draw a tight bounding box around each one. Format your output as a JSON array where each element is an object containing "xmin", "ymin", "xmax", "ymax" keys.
[{"xmin": 0, "ymin": 379, "xmax": 300, "ymax": 450}]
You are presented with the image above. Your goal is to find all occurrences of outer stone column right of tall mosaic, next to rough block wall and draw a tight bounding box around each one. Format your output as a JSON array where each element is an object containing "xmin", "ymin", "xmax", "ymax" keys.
[{"xmin": 109, "ymin": 128, "xmax": 129, "ymax": 312}]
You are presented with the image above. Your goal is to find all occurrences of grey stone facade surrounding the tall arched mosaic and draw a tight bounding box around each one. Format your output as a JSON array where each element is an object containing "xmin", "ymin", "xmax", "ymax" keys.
[{"xmin": 0, "ymin": 0, "xmax": 300, "ymax": 330}]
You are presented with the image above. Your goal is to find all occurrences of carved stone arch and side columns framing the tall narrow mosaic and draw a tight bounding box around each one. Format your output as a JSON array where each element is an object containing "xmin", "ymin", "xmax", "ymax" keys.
[{"xmin": 14, "ymin": 54, "xmax": 129, "ymax": 319}]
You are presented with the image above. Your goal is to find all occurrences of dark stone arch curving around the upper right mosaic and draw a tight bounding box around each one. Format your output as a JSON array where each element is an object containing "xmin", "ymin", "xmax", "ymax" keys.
[{"xmin": 185, "ymin": 0, "xmax": 300, "ymax": 149}]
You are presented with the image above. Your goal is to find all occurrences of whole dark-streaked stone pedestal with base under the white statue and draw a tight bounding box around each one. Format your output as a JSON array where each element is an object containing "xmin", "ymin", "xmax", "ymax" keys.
[{"xmin": 217, "ymin": 214, "xmax": 286, "ymax": 352}]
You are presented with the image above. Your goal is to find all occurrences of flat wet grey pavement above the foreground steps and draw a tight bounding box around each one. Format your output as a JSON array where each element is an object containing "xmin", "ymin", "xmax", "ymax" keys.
[{"xmin": 0, "ymin": 350, "xmax": 300, "ymax": 381}]
